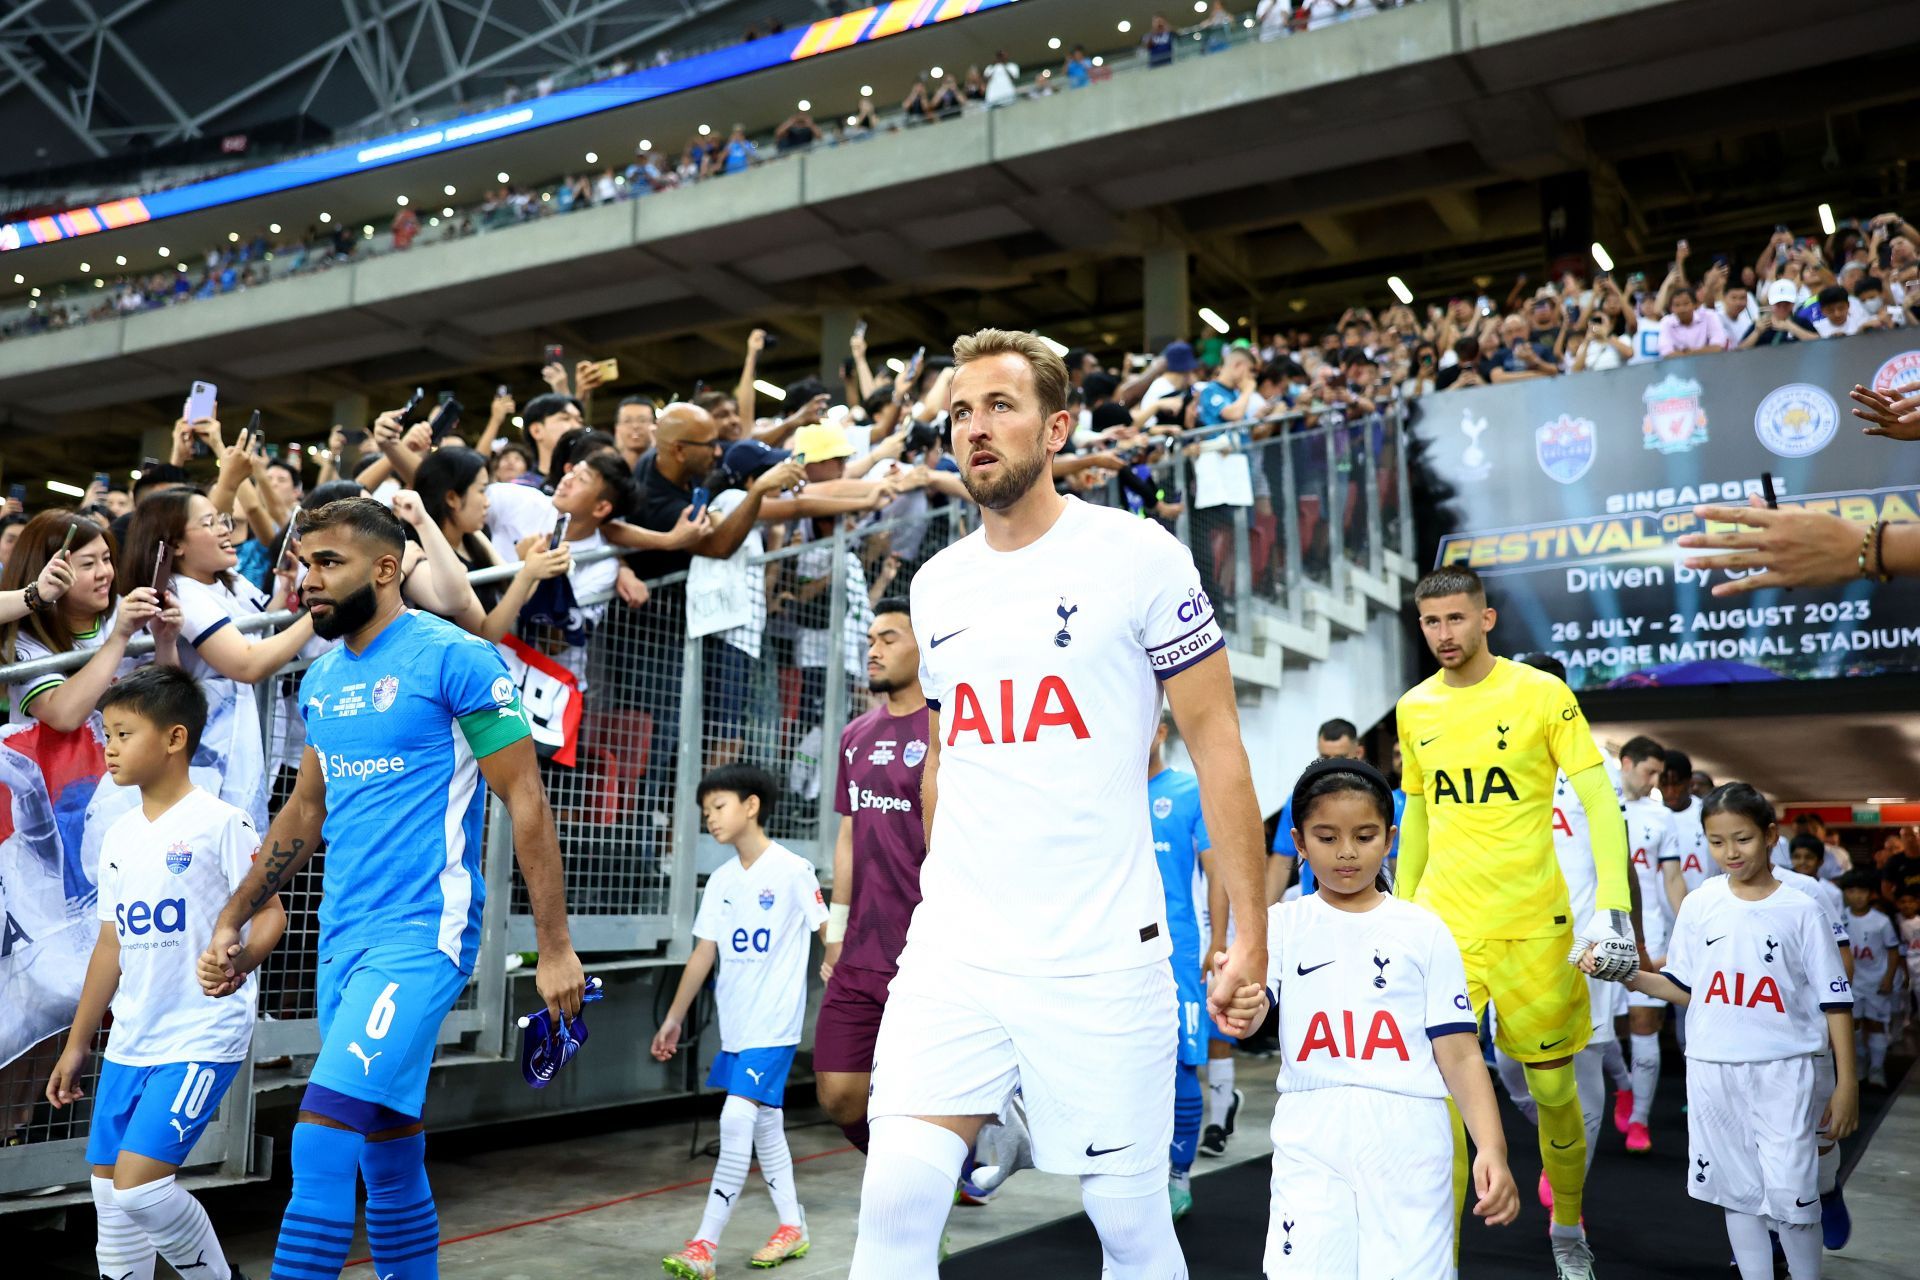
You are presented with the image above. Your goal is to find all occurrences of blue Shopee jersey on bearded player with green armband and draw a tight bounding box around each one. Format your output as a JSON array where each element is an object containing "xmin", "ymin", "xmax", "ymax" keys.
[{"xmin": 300, "ymin": 612, "xmax": 532, "ymax": 973}]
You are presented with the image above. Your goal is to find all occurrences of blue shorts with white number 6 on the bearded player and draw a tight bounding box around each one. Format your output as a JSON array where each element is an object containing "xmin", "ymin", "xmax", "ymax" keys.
[{"xmin": 309, "ymin": 946, "xmax": 467, "ymax": 1119}]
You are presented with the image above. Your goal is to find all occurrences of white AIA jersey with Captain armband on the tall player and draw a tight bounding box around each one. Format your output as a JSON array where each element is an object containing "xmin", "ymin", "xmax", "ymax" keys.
[{"xmin": 906, "ymin": 497, "xmax": 1225, "ymax": 975}]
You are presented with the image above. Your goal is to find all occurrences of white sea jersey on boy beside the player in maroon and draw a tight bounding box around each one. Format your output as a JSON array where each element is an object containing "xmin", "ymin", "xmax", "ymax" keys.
[{"xmin": 693, "ymin": 844, "xmax": 828, "ymax": 1054}]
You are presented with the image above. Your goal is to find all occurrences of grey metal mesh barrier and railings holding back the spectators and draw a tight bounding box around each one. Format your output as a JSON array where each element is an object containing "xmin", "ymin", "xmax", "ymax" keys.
[{"xmin": 0, "ymin": 405, "xmax": 1413, "ymax": 1213}]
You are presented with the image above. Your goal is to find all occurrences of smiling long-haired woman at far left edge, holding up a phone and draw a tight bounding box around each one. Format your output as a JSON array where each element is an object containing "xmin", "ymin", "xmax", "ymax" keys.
[{"xmin": 0, "ymin": 510, "xmax": 180, "ymax": 733}]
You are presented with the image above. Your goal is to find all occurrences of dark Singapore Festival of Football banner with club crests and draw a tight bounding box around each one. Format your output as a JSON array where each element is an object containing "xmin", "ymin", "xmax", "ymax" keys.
[{"xmin": 1413, "ymin": 330, "xmax": 1920, "ymax": 689}]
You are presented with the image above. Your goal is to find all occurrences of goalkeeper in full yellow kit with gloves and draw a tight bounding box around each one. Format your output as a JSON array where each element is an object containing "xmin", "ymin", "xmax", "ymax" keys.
[{"xmin": 1394, "ymin": 568, "xmax": 1640, "ymax": 1280}]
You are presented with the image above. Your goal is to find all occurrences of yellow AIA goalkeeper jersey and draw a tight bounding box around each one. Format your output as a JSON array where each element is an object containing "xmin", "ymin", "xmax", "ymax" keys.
[{"xmin": 1398, "ymin": 658, "xmax": 1601, "ymax": 938}]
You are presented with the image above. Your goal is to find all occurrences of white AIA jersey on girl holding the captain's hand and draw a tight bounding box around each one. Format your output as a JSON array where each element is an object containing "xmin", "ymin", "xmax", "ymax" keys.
[{"xmin": 1267, "ymin": 894, "xmax": 1475, "ymax": 1098}]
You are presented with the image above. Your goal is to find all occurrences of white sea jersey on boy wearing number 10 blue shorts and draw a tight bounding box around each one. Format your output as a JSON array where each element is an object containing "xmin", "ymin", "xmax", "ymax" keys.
[{"xmin": 98, "ymin": 787, "xmax": 259, "ymax": 1067}]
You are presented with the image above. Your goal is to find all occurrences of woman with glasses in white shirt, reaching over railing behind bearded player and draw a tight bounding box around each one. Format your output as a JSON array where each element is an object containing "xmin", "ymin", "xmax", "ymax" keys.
[{"xmin": 123, "ymin": 487, "xmax": 313, "ymax": 831}]
